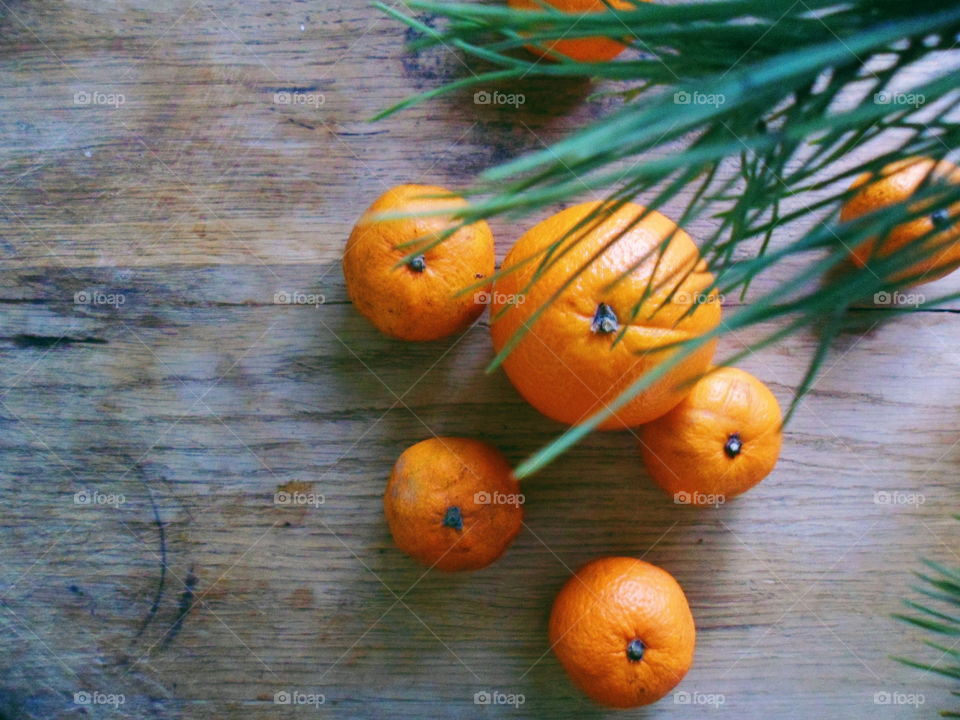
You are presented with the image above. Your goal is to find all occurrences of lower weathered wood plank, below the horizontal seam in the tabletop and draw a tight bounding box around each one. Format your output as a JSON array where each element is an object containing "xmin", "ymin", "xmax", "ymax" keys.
[{"xmin": 0, "ymin": 258, "xmax": 960, "ymax": 717}]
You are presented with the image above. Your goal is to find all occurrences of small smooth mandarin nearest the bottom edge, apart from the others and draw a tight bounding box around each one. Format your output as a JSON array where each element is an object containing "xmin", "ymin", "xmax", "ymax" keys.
[{"xmin": 550, "ymin": 557, "xmax": 696, "ymax": 708}]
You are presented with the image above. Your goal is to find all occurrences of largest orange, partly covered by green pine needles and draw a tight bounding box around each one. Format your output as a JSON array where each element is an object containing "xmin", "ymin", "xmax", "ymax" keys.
[{"xmin": 490, "ymin": 202, "xmax": 721, "ymax": 430}]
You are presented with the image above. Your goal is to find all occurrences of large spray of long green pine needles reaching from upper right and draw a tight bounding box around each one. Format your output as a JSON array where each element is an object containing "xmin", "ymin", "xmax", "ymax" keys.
[{"xmin": 377, "ymin": 0, "xmax": 960, "ymax": 477}]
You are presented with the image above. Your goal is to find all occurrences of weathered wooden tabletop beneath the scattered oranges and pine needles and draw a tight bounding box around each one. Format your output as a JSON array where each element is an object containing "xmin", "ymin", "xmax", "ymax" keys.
[{"xmin": 0, "ymin": 0, "xmax": 960, "ymax": 720}]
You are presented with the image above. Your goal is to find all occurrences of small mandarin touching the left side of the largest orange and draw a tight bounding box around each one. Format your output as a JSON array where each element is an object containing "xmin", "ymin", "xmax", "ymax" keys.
[{"xmin": 343, "ymin": 185, "xmax": 494, "ymax": 340}]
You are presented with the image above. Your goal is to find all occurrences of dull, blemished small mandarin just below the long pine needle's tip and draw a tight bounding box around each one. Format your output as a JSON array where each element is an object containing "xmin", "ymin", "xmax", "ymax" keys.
[{"xmin": 383, "ymin": 437, "xmax": 523, "ymax": 571}]
